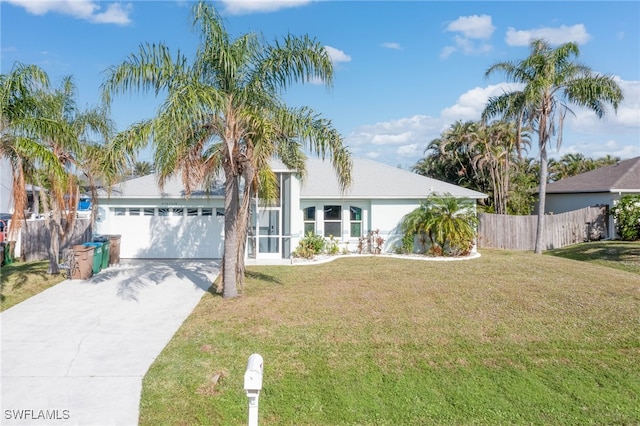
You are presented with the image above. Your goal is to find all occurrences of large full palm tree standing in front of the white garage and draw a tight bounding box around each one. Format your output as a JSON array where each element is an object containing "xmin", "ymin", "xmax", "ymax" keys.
[{"xmin": 103, "ymin": 1, "xmax": 351, "ymax": 298}]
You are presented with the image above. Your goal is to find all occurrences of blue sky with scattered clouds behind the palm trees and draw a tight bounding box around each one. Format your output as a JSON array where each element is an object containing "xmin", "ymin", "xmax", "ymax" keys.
[{"xmin": 0, "ymin": 0, "xmax": 640, "ymax": 168}]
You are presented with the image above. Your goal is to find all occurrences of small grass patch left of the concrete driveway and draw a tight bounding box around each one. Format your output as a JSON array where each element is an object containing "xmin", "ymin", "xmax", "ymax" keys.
[{"xmin": 0, "ymin": 261, "xmax": 64, "ymax": 312}]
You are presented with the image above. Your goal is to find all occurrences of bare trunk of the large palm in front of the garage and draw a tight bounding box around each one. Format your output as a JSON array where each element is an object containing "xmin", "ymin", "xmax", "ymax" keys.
[{"xmin": 222, "ymin": 165, "xmax": 238, "ymax": 299}]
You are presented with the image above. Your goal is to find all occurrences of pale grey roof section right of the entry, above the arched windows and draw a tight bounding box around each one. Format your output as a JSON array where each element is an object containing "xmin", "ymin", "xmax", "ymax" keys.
[{"xmin": 300, "ymin": 158, "xmax": 486, "ymax": 199}]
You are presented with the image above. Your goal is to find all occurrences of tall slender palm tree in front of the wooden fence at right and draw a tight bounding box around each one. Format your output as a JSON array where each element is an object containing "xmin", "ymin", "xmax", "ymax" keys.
[{"xmin": 482, "ymin": 40, "xmax": 623, "ymax": 254}]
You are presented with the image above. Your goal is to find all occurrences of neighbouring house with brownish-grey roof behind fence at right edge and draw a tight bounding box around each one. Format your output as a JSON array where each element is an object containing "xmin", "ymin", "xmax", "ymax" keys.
[{"xmin": 545, "ymin": 157, "xmax": 640, "ymax": 238}]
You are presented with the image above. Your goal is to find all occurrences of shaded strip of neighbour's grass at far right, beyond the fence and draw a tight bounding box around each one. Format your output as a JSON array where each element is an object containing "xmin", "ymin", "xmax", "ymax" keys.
[{"xmin": 545, "ymin": 241, "xmax": 640, "ymax": 274}]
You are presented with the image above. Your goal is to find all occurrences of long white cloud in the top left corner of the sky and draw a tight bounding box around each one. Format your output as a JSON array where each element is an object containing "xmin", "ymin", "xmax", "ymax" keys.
[{"xmin": 5, "ymin": 0, "xmax": 132, "ymax": 25}]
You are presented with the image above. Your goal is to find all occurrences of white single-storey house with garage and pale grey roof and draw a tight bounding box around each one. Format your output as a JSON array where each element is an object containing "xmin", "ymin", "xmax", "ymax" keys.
[{"xmin": 96, "ymin": 158, "xmax": 486, "ymax": 260}]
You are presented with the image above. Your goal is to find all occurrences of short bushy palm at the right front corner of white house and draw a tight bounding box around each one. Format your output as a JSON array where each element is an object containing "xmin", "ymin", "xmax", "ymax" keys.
[{"xmin": 402, "ymin": 194, "xmax": 478, "ymax": 256}]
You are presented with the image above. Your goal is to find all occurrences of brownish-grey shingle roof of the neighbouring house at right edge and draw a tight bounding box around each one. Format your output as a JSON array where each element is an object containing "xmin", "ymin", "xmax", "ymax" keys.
[{"xmin": 547, "ymin": 157, "xmax": 640, "ymax": 194}]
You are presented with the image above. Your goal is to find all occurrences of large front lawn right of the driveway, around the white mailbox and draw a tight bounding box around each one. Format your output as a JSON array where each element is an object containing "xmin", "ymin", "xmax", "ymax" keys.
[{"xmin": 140, "ymin": 248, "xmax": 640, "ymax": 425}]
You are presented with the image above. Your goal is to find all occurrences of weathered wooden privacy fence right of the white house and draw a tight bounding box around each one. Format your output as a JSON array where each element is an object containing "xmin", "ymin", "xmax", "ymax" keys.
[{"xmin": 478, "ymin": 206, "xmax": 609, "ymax": 250}]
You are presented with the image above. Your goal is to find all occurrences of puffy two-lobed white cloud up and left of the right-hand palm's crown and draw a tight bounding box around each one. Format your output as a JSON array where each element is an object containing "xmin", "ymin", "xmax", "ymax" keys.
[{"xmin": 440, "ymin": 15, "xmax": 495, "ymax": 59}]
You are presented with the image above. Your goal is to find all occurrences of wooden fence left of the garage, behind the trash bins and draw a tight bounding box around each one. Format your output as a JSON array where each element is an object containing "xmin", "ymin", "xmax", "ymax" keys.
[{"xmin": 20, "ymin": 219, "xmax": 93, "ymax": 262}]
